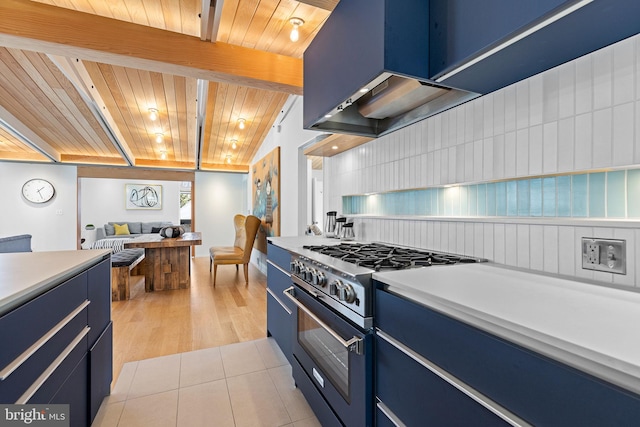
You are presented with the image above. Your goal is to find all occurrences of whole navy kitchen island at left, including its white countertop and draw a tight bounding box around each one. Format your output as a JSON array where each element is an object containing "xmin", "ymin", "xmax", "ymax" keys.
[{"xmin": 0, "ymin": 250, "xmax": 112, "ymax": 426}]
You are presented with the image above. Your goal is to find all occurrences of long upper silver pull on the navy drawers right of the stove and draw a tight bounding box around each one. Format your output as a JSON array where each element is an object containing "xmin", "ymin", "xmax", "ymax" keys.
[{"xmin": 376, "ymin": 329, "xmax": 531, "ymax": 427}]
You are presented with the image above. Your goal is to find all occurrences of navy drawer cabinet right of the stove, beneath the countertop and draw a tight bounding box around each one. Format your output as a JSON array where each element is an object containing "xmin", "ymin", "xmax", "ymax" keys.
[{"xmin": 375, "ymin": 289, "xmax": 640, "ymax": 426}]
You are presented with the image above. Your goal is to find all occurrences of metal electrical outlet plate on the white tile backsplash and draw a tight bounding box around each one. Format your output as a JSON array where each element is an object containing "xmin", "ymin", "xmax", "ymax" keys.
[{"xmin": 582, "ymin": 237, "xmax": 627, "ymax": 274}]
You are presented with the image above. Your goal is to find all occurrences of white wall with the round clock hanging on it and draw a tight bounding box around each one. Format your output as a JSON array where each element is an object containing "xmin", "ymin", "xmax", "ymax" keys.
[{"xmin": 0, "ymin": 162, "xmax": 77, "ymax": 251}]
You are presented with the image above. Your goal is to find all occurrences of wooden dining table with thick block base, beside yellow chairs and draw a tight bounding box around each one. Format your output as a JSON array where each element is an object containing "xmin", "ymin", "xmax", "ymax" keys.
[{"xmin": 124, "ymin": 232, "xmax": 202, "ymax": 292}]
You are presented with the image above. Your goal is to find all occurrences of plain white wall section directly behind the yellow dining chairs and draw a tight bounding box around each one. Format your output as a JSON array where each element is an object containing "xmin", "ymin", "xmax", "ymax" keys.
[{"xmin": 195, "ymin": 172, "xmax": 250, "ymax": 257}]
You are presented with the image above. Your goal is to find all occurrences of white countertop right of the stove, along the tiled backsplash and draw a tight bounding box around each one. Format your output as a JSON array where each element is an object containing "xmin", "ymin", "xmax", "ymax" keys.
[{"xmin": 373, "ymin": 264, "xmax": 640, "ymax": 393}]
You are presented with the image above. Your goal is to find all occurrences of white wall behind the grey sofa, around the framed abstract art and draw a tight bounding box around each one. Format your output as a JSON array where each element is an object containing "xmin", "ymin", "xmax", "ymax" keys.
[{"xmin": 80, "ymin": 178, "xmax": 181, "ymax": 242}]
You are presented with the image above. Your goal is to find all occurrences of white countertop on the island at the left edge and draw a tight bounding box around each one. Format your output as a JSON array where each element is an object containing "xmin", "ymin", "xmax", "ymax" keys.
[{"xmin": 0, "ymin": 249, "xmax": 111, "ymax": 315}]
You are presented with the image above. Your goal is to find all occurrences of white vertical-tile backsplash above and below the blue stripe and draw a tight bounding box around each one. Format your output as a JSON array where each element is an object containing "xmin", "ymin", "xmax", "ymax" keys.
[{"xmin": 324, "ymin": 32, "xmax": 640, "ymax": 287}]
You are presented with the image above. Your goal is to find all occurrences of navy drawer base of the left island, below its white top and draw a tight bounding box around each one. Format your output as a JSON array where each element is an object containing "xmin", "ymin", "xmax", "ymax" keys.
[{"xmin": 0, "ymin": 256, "xmax": 112, "ymax": 426}]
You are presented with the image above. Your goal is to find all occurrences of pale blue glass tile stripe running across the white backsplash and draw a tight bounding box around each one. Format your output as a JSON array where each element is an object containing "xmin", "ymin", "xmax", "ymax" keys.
[{"xmin": 342, "ymin": 169, "xmax": 640, "ymax": 219}]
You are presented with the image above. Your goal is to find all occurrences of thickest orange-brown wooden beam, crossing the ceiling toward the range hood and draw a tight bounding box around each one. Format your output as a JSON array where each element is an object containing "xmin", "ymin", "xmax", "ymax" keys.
[{"xmin": 0, "ymin": 0, "xmax": 303, "ymax": 95}]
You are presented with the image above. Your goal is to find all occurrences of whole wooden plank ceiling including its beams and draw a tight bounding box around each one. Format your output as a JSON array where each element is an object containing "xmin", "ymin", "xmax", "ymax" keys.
[{"xmin": 0, "ymin": 0, "xmax": 338, "ymax": 172}]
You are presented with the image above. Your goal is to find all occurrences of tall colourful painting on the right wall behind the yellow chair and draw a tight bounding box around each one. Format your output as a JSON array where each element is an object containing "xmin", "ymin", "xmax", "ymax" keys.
[{"xmin": 251, "ymin": 147, "xmax": 280, "ymax": 254}]
